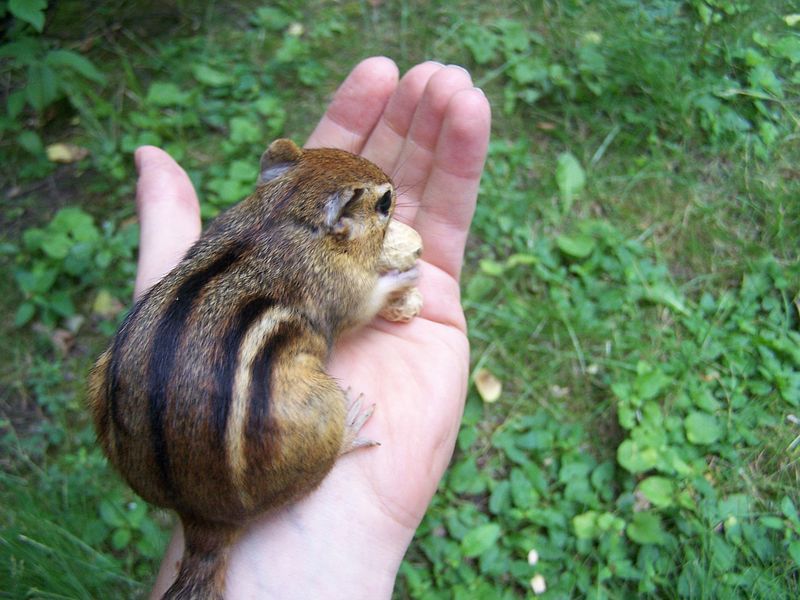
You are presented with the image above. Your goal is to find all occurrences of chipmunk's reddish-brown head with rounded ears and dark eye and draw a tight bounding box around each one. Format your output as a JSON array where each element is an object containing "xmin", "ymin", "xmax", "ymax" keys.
[{"xmin": 258, "ymin": 139, "xmax": 396, "ymax": 256}]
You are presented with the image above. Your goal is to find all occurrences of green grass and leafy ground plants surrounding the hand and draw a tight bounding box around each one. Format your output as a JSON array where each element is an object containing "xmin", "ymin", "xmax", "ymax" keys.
[{"xmin": 0, "ymin": 0, "xmax": 800, "ymax": 599}]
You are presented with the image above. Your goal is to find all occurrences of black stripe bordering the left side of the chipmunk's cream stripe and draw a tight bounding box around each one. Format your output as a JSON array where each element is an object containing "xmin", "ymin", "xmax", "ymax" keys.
[{"xmin": 211, "ymin": 298, "xmax": 275, "ymax": 447}]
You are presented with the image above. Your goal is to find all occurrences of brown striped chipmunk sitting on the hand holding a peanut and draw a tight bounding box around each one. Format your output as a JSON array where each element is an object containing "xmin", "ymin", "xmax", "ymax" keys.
[{"xmin": 88, "ymin": 139, "xmax": 417, "ymax": 599}]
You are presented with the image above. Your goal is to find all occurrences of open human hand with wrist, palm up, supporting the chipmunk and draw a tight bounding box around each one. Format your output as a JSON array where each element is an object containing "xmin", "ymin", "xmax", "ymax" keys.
[{"xmin": 143, "ymin": 58, "xmax": 490, "ymax": 599}]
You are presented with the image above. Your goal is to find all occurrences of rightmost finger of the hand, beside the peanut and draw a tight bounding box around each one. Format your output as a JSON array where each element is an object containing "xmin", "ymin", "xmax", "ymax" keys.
[{"xmin": 413, "ymin": 88, "xmax": 491, "ymax": 278}]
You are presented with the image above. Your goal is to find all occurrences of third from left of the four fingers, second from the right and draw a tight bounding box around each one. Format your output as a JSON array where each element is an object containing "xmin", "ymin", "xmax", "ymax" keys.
[{"xmin": 391, "ymin": 66, "xmax": 472, "ymax": 223}]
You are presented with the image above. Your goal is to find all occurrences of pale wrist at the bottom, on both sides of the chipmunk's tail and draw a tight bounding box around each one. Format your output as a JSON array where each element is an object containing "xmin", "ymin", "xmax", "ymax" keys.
[{"xmin": 153, "ymin": 460, "xmax": 414, "ymax": 600}]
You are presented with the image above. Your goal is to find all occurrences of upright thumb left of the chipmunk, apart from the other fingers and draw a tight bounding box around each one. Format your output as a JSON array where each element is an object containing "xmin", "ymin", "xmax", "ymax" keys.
[{"xmin": 134, "ymin": 146, "xmax": 200, "ymax": 298}]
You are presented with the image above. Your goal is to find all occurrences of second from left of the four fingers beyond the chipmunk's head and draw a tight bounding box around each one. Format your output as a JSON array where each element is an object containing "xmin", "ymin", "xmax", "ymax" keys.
[{"xmin": 361, "ymin": 61, "xmax": 444, "ymax": 173}]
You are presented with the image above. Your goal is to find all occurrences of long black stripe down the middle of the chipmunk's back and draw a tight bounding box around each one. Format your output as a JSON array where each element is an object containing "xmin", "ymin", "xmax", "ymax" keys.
[{"xmin": 147, "ymin": 243, "xmax": 245, "ymax": 490}]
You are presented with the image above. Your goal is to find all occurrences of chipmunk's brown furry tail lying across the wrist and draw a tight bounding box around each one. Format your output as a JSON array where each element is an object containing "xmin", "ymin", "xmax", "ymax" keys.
[{"xmin": 162, "ymin": 517, "xmax": 239, "ymax": 600}]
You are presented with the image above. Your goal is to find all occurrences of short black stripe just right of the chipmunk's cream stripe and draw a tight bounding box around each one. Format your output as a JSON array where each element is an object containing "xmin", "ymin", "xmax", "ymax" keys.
[{"xmin": 247, "ymin": 321, "xmax": 301, "ymax": 439}]
